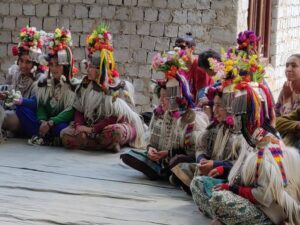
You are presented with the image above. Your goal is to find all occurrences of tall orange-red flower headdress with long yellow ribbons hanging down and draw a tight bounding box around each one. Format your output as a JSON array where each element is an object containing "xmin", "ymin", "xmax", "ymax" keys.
[{"xmin": 86, "ymin": 23, "xmax": 120, "ymax": 89}]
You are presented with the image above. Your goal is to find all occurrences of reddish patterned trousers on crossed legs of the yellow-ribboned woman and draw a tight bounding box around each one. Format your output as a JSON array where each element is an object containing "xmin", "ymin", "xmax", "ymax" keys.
[{"xmin": 61, "ymin": 123, "xmax": 136, "ymax": 150}]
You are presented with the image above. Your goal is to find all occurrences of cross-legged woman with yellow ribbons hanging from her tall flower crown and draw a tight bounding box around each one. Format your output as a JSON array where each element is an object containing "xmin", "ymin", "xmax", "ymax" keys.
[{"xmin": 61, "ymin": 24, "xmax": 144, "ymax": 152}]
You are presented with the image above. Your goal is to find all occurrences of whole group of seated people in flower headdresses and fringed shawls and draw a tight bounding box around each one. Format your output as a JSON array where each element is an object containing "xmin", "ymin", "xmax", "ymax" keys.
[{"xmin": 0, "ymin": 24, "xmax": 300, "ymax": 225}]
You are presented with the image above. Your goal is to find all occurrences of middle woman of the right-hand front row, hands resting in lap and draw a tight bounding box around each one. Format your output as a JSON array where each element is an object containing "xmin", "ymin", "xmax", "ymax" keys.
[{"xmin": 172, "ymin": 85, "xmax": 242, "ymax": 195}]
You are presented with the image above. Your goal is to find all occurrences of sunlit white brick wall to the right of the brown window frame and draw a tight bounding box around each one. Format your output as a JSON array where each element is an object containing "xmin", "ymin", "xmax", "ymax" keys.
[{"xmin": 270, "ymin": 0, "xmax": 300, "ymax": 100}]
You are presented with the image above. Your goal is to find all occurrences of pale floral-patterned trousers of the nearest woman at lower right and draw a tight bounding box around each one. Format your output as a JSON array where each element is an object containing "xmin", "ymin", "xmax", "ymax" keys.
[{"xmin": 191, "ymin": 177, "xmax": 273, "ymax": 225}]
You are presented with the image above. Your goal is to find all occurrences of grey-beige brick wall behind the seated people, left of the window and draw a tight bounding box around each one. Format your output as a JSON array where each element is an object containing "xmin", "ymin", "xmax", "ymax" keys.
[{"xmin": 0, "ymin": 0, "xmax": 243, "ymax": 111}]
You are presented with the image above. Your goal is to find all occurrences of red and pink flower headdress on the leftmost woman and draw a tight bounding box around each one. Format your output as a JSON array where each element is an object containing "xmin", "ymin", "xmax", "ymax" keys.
[{"xmin": 12, "ymin": 26, "xmax": 43, "ymax": 62}]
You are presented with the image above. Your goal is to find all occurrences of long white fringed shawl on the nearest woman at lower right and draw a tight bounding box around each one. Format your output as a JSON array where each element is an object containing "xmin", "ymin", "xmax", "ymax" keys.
[{"xmin": 229, "ymin": 134, "xmax": 300, "ymax": 225}]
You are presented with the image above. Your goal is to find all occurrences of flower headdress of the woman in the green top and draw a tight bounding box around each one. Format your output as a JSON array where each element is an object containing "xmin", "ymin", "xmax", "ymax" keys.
[{"xmin": 47, "ymin": 28, "xmax": 78, "ymax": 80}]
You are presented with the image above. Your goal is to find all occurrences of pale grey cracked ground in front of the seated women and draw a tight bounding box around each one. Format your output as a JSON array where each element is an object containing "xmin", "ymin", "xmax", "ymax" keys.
[{"xmin": 0, "ymin": 139, "xmax": 210, "ymax": 225}]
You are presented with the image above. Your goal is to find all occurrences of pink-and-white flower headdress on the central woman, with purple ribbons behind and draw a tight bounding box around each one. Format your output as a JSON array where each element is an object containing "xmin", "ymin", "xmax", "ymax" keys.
[{"xmin": 151, "ymin": 48, "xmax": 195, "ymax": 108}]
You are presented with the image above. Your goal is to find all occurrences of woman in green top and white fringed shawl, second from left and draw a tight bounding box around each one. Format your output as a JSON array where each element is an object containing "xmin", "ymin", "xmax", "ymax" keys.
[{"xmin": 19, "ymin": 28, "xmax": 75, "ymax": 145}]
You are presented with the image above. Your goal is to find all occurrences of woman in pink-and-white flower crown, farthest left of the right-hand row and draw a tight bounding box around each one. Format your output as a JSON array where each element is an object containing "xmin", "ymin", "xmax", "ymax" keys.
[{"xmin": 121, "ymin": 48, "xmax": 208, "ymax": 180}]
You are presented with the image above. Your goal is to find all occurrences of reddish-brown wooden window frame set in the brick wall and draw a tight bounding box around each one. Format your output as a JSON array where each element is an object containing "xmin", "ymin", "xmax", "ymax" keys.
[{"xmin": 248, "ymin": 0, "xmax": 272, "ymax": 61}]
